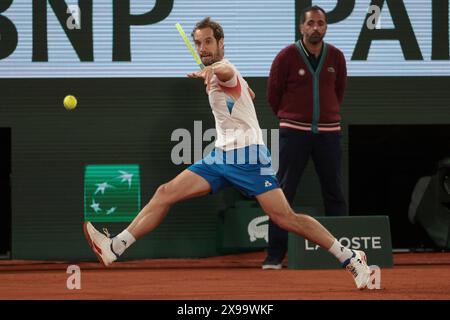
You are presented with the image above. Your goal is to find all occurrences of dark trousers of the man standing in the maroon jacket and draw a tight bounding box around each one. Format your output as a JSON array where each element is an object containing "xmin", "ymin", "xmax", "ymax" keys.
[{"xmin": 268, "ymin": 128, "xmax": 347, "ymax": 260}]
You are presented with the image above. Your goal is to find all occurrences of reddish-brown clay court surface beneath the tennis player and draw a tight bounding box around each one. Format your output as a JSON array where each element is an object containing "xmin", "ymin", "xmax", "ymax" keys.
[{"xmin": 0, "ymin": 252, "xmax": 450, "ymax": 300}]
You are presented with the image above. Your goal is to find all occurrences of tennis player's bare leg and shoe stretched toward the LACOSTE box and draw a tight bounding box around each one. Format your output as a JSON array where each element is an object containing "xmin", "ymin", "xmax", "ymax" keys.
[{"xmin": 256, "ymin": 188, "xmax": 370, "ymax": 289}]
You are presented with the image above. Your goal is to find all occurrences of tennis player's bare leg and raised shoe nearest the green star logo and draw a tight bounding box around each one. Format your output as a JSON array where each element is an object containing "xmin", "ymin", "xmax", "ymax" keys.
[{"xmin": 84, "ymin": 170, "xmax": 211, "ymax": 266}]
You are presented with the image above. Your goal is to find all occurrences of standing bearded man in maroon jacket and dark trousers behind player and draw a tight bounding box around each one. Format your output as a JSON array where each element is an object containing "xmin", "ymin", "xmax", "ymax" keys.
[{"xmin": 262, "ymin": 6, "xmax": 347, "ymax": 269}]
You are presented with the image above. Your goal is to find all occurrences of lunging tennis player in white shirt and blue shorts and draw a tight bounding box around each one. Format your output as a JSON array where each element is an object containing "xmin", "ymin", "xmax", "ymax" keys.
[{"xmin": 84, "ymin": 18, "xmax": 370, "ymax": 289}]
